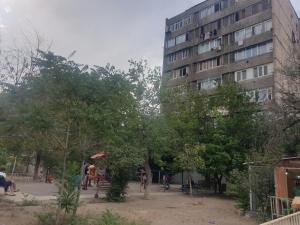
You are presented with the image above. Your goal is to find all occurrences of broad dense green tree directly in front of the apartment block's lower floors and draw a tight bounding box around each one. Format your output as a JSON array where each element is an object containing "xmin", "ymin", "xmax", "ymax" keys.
[{"xmin": 164, "ymin": 84, "xmax": 259, "ymax": 192}]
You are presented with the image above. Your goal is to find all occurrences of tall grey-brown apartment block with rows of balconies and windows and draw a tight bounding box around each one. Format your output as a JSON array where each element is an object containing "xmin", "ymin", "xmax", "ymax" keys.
[{"xmin": 163, "ymin": 0, "xmax": 300, "ymax": 102}]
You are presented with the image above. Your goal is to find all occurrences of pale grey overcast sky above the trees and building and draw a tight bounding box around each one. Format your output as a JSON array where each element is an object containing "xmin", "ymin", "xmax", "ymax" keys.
[{"xmin": 0, "ymin": 0, "xmax": 300, "ymax": 69}]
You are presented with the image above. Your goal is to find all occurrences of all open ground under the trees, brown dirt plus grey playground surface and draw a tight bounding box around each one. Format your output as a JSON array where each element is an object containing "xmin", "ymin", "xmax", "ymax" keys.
[{"xmin": 0, "ymin": 182, "xmax": 256, "ymax": 225}]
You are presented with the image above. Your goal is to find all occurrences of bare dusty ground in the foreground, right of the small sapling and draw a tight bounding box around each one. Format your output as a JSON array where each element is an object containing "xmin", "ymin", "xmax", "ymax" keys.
[{"xmin": 80, "ymin": 194, "xmax": 256, "ymax": 225}]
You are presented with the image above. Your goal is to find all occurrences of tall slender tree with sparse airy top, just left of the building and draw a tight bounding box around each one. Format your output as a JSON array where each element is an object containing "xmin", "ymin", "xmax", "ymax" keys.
[{"xmin": 127, "ymin": 60, "xmax": 170, "ymax": 199}]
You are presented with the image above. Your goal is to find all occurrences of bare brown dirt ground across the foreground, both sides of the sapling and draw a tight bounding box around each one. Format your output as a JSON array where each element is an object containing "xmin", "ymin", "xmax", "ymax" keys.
[{"xmin": 0, "ymin": 193, "xmax": 256, "ymax": 225}]
